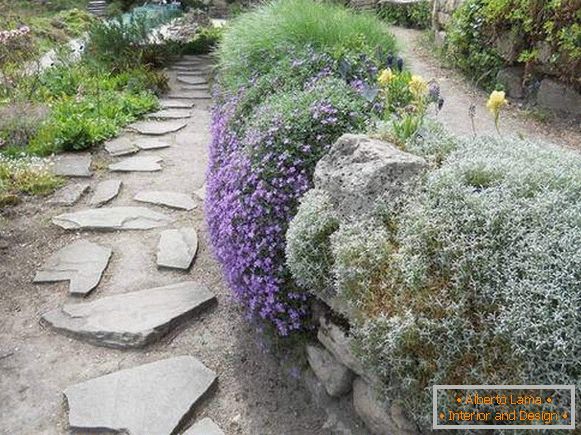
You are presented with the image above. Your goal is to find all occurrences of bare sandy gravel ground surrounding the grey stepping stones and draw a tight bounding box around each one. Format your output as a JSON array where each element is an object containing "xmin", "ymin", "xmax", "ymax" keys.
[{"xmin": 0, "ymin": 55, "xmax": 325, "ymax": 435}]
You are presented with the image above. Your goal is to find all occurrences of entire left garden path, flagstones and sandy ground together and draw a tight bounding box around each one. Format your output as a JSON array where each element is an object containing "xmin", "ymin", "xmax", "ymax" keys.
[{"xmin": 0, "ymin": 57, "xmax": 328, "ymax": 435}]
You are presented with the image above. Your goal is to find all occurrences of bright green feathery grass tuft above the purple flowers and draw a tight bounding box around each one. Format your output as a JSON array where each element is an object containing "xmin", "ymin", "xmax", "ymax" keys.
[{"xmin": 218, "ymin": 0, "xmax": 395, "ymax": 88}]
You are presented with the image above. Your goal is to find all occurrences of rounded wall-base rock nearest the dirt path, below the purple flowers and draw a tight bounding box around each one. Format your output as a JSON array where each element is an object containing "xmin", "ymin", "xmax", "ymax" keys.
[{"xmin": 306, "ymin": 345, "xmax": 353, "ymax": 397}]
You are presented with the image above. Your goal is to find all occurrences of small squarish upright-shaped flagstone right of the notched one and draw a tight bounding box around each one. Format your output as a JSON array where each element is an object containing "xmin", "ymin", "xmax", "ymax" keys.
[{"xmin": 157, "ymin": 228, "xmax": 198, "ymax": 270}]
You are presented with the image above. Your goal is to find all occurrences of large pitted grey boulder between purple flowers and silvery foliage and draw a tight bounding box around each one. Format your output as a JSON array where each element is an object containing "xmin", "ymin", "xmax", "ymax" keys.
[{"xmin": 314, "ymin": 134, "xmax": 427, "ymax": 220}]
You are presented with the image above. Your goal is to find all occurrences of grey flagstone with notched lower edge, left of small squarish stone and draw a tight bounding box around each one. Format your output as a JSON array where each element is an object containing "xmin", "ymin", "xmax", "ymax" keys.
[{"xmin": 33, "ymin": 240, "xmax": 111, "ymax": 296}]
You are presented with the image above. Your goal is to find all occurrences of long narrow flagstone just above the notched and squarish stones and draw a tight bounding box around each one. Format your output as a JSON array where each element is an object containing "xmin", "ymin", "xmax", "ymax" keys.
[{"xmin": 52, "ymin": 207, "xmax": 173, "ymax": 231}]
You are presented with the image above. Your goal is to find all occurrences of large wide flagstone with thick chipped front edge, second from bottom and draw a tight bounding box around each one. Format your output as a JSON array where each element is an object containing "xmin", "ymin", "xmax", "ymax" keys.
[{"xmin": 41, "ymin": 281, "xmax": 216, "ymax": 350}]
